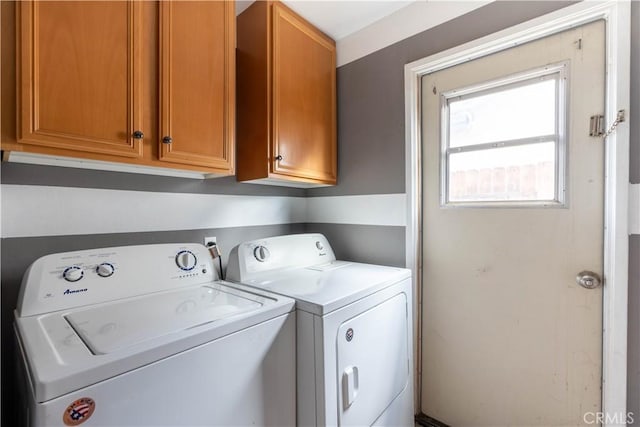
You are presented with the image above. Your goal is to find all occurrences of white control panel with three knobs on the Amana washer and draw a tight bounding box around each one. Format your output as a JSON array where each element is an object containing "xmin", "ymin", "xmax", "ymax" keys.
[{"xmin": 16, "ymin": 243, "xmax": 218, "ymax": 316}]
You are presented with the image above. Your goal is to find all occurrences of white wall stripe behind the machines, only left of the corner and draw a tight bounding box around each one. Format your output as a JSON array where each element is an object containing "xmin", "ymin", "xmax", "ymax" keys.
[{"xmin": 1, "ymin": 184, "xmax": 306, "ymax": 237}]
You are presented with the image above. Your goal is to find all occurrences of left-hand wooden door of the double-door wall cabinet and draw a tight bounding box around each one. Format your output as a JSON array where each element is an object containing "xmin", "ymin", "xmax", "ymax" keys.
[{"xmin": 17, "ymin": 1, "xmax": 143, "ymax": 157}]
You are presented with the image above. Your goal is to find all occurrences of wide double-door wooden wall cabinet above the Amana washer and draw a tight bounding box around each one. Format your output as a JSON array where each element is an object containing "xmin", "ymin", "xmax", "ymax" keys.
[{"xmin": 7, "ymin": 0, "xmax": 235, "ymax": 175}]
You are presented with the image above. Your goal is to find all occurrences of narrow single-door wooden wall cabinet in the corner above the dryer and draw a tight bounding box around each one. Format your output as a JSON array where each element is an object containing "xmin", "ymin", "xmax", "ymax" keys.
[{"xmin": 237, "ymin": 1, "xmax": 337, "ymax": 187}]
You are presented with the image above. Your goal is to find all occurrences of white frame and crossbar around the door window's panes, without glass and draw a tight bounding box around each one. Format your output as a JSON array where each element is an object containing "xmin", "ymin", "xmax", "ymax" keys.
[{"xmin": 439, "ymin": 61, "xmax": 569, "ymax": 208}]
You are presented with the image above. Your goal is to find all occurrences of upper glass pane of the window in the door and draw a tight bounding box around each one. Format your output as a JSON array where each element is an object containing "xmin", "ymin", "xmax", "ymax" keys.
[{"xmin": 448, "ymin": 79, "xmax": 557, "ymax": 147}]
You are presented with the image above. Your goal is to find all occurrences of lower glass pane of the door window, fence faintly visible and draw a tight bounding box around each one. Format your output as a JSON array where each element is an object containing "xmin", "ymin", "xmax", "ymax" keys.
[{"xmin": 449, "ymin": 141, "xmax": 556, "ymax": 202}]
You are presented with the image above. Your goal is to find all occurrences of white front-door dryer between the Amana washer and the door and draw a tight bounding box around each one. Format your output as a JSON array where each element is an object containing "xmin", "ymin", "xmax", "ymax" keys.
[{"xmin": 227, "ymin": 234, "xmax": 414, "ymax": 426}]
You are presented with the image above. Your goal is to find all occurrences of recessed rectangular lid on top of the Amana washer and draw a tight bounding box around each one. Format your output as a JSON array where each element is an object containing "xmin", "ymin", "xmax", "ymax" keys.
[{"xmin": 64, "ymin": 285, "xmax": 262, "ymax": 354}]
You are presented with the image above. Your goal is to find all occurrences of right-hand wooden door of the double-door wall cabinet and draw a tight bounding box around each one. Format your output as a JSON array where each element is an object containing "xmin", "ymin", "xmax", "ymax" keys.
[{"xmin": 160, "ymin": 1, "xmax": 235, "ymax": 173}]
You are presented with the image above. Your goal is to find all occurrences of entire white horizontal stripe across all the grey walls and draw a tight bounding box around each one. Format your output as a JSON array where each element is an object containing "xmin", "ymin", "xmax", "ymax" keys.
[{"xmin": 0, "ymin": 184, "xmax": 640, "ymax": 238}]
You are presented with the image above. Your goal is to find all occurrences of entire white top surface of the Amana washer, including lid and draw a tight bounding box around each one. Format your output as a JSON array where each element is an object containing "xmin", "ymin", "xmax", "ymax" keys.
[{"xmin": 14, "ymin": 281, "xmax": 295, "ymax": 402}]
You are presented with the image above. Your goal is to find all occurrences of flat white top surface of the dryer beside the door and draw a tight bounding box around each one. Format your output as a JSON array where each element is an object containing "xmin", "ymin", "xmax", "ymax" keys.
[{"xmin": 244, "ymin": 261, "xmax": 411, "ymax": 316}]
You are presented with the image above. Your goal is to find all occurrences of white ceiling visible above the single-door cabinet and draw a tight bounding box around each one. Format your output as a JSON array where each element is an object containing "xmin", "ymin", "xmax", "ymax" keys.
[{"xmin": 236, "ymin": 0, "xmax": 416, "ymax": 41}]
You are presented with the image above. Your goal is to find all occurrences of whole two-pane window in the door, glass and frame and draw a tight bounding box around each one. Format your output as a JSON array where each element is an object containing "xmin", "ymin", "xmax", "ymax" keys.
[{"xmin": 440, "ymin": 63, "xmax": 567, "ymax": 206}]
